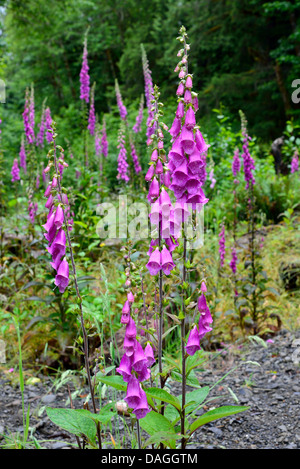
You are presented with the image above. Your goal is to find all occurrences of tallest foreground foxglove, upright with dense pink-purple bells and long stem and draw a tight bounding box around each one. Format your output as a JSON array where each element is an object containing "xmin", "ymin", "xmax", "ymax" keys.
[{"xmin": 168, "ymin": 26, "xmax": 209, "ymax": 448}]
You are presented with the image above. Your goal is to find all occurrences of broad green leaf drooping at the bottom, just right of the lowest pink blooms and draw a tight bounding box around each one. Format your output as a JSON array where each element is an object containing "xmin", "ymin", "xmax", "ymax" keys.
[{"xmin": 140, "ymin": 410, "xmax": 176, "ymax": 449}]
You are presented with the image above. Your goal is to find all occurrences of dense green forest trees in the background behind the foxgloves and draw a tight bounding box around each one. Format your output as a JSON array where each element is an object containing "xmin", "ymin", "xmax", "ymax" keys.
[{"xmin": 0, "ymin": 0, "xmax": 300, "ymax": 154}]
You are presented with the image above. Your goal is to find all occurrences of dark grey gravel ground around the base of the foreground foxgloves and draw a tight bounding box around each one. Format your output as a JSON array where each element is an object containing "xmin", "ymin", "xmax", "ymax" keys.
[{"xmin": 0, "ymin": 331, "xmax": 300, "ymax": 449}]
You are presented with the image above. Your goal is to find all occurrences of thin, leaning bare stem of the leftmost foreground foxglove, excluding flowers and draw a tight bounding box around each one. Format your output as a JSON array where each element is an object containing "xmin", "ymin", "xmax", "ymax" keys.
[{"xmin": 53, "ymin": 124, "xmax": 102, "ymax": 449}]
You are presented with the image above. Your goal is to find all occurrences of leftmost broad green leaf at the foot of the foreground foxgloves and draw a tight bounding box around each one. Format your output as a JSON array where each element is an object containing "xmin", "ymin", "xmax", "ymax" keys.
[{"xmin": 46, "ymin": 407, "xmax": 96, "ymax": 442}]
